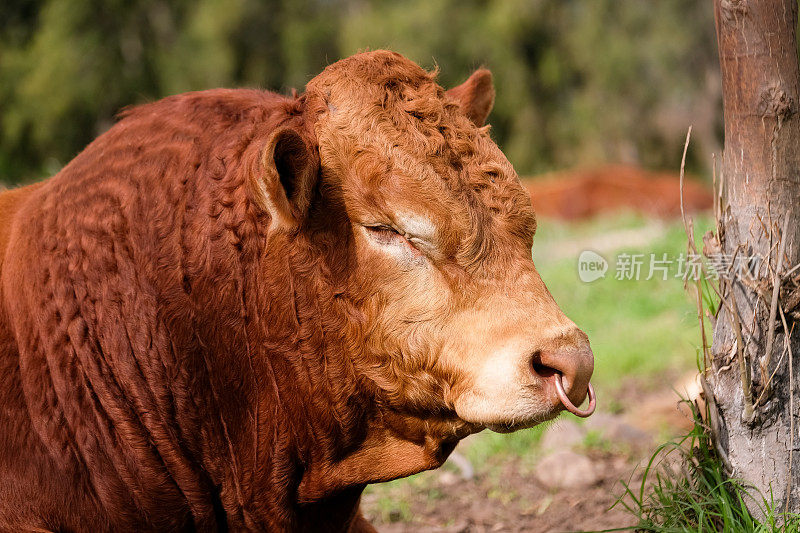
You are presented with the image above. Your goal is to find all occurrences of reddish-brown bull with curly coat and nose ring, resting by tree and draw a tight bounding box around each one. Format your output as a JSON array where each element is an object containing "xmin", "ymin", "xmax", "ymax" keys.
[{"xmin": 0, "ymin": 51, "xmax": 593, "ymax": 531}]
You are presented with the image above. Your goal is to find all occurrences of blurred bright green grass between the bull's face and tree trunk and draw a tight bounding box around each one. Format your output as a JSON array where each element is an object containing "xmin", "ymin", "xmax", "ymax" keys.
[{"xmin": 534, "ymin": 216, "xmax": 710, "ymax": 395}]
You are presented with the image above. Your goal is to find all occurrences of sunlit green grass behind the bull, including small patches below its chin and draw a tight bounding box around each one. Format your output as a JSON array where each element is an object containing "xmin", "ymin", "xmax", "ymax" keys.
[{"xmin": 367, "ymin": 214, "xmax": 712, "ymax": 520}]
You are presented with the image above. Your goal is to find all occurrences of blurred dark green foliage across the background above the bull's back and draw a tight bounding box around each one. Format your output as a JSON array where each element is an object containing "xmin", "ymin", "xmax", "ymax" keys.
[{"xmin": 0, "ymin": 0, "xmax": 721, "ymax": 184}]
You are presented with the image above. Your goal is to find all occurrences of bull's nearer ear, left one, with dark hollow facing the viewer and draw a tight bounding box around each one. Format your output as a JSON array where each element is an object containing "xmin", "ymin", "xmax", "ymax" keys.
[{"xmin": 253, "ymin": 127, "xmax": 319, "ymax": 229}]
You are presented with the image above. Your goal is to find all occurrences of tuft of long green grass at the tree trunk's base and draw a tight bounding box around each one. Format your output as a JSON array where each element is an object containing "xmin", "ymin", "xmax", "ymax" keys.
[{"xmin": 617, "ymin": 402, "xmax": 800, "ymax": 533}]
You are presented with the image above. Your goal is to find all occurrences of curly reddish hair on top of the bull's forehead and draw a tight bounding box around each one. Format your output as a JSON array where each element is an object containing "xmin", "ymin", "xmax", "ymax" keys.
[{"xmin": 307, "ymin": 50, "xmax": 535, "ymax": 256}]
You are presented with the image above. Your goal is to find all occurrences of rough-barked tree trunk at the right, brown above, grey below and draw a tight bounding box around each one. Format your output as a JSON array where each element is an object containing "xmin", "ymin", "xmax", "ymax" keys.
[{"xmin": 705, "ymin": 0, "xmax": 800, "ymax": 512}]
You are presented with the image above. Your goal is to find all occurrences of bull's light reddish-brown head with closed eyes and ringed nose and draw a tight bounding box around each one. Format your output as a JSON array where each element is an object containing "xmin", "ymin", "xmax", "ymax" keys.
[{"xmin": 250, "ymin": 51, "xmax": 593, "ymax": 440}]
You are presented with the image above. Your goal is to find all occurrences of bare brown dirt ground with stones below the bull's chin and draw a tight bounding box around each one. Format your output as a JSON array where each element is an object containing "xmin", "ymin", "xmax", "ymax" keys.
[{"xmin": 363, "ymin": 376, "xmax": 694, "ymax": 533}]
